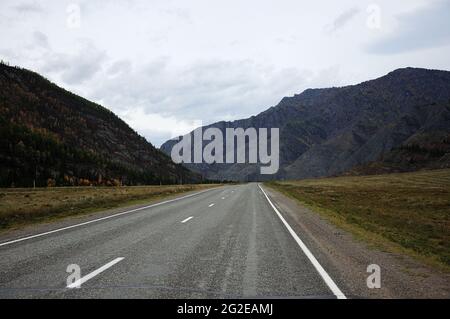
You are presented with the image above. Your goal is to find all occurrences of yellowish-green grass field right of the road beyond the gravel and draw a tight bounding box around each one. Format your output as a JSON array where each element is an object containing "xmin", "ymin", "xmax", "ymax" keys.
[{"xmin": 268, "ymin": 169, "xmax": 450, "ymax": 270}]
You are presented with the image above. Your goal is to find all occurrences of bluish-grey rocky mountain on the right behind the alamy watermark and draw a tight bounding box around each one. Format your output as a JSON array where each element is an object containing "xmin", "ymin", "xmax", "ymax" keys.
[{"xmin": 161, "ymin": 68, "xmax": 450, "ymax": 180}]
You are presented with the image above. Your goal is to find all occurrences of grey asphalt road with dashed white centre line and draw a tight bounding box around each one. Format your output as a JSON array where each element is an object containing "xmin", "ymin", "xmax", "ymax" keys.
[{"xmin": 0, "ymin": 183, "xmax": 343, "ymax": 298}]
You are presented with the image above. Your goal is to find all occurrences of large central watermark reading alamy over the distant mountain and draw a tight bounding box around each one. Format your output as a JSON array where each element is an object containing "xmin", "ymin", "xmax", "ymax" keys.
[{"xmin": 171, "ymin": 127, "xmax": 280, "ymax": 174}]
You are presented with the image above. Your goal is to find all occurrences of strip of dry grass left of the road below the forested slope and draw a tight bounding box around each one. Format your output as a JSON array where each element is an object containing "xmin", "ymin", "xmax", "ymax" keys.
[{"xmin": 0, "ymin": 184, "xmax": 217, "ymax": 230}]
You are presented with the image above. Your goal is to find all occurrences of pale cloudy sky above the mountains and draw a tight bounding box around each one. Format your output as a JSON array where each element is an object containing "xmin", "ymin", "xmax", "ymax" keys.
[{"xmin": 0, "ymin": 0, "xmax": 450, "ymax": 146}]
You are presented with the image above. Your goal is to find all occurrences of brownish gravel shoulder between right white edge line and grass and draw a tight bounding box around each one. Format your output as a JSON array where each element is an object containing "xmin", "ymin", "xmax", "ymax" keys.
[{"xmin": 264, "ymin": 186, "xmax": 450, "ymax": 298}]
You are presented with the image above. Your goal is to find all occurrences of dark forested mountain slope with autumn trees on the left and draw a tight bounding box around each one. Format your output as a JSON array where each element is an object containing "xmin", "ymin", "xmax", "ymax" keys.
[{"xmin": 0, "ymin": 63, "xmax": 201, "ymax": 187}]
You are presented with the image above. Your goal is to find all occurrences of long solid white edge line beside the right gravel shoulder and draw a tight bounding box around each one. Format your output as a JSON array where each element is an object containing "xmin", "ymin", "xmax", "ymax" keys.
[{"xmin": 258, "ymin": 184, "xmax": 347, "ymax": 299}]
